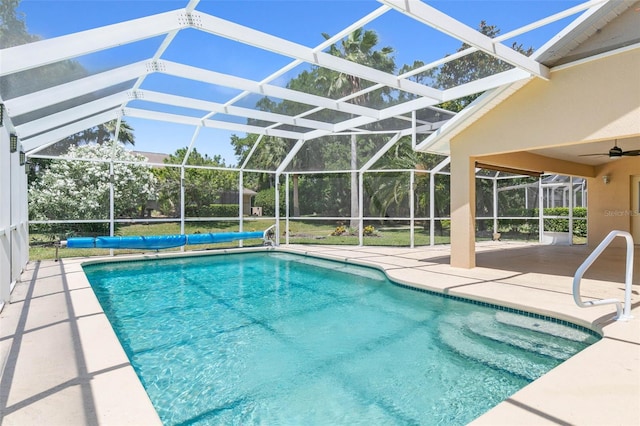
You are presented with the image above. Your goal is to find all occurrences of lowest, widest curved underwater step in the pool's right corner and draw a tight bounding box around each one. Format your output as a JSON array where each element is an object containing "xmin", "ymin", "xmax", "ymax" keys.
[{"xmin": 438, "ymin": 316, "xmax": 558, "ymax": 381}]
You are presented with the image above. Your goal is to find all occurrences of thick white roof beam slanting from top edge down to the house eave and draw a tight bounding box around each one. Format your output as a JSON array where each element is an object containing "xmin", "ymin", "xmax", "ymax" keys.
[{"xmin": 379, "ymin": 0, "xmax": 550, "ymax": 80}]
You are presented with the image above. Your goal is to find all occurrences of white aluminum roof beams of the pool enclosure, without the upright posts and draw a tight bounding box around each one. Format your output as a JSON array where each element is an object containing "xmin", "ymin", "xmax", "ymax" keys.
[{"xmin": 0, "ymin": 0, "xmax": 606, "ymax": 159}]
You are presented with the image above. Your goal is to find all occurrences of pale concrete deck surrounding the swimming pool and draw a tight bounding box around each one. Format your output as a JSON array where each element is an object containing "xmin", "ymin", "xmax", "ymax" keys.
[{"xmin": 0, "ymin": 242, "xmax": 640, "ymax": 426}]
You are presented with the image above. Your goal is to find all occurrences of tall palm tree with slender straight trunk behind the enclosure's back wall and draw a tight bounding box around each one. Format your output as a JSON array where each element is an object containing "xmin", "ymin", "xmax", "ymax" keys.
[{"xmin": 319, "ymin": 28, "xmax": 396, "ymax": 228}]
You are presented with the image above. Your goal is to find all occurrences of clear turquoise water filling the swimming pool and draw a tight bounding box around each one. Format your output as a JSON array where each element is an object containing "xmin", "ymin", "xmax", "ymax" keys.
[{"xmin": 84, "ymin": 252, "xmax": 598, "ymax": 425}]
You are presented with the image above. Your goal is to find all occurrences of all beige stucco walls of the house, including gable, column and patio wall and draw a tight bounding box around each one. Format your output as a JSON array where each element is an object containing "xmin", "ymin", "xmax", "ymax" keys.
[{"xmin": 450, "ymin": 49, "xmax": 640, "ymax": 267}]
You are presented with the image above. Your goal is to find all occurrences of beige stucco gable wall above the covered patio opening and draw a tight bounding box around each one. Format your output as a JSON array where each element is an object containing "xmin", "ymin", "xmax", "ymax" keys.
[{"xmin": 451, "ymin": 49, "xmax": 640, "ymax": 155}]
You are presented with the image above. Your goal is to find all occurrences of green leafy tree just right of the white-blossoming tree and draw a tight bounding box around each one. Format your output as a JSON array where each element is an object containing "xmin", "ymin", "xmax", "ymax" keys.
[{"xmin": 154, "ymin": 148, "xmax": 237, "ymax": 215}]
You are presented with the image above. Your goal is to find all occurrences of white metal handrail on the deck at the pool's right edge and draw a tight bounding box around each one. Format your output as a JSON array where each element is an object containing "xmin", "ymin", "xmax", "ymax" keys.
[{"xmin": 573, "ymin": 230, "xmax": 633, "ymax": 321}]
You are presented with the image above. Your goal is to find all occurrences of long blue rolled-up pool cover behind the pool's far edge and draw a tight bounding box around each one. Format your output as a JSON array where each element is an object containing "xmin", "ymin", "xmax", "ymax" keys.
[{"xmin": 67, "ymin": 231, "xmax": 264, "ymax": 250}]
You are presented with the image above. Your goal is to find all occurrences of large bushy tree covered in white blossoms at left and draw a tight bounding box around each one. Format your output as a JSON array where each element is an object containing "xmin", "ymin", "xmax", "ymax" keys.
[{"xmin": 29, "ymin": 144, "xmax": 157, "ymax": 235}]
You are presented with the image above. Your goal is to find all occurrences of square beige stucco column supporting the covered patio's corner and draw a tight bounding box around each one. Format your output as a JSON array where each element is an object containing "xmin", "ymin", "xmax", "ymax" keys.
[{"xmin": 451, "ymin": 151, "xmax": 476, "ymax": 268}]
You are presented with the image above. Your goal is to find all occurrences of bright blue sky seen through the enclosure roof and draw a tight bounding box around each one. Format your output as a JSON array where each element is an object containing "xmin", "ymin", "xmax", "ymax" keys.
[{"xmin": 18, "ymin": 0, "xmax": 581, "ymax": 165}]
